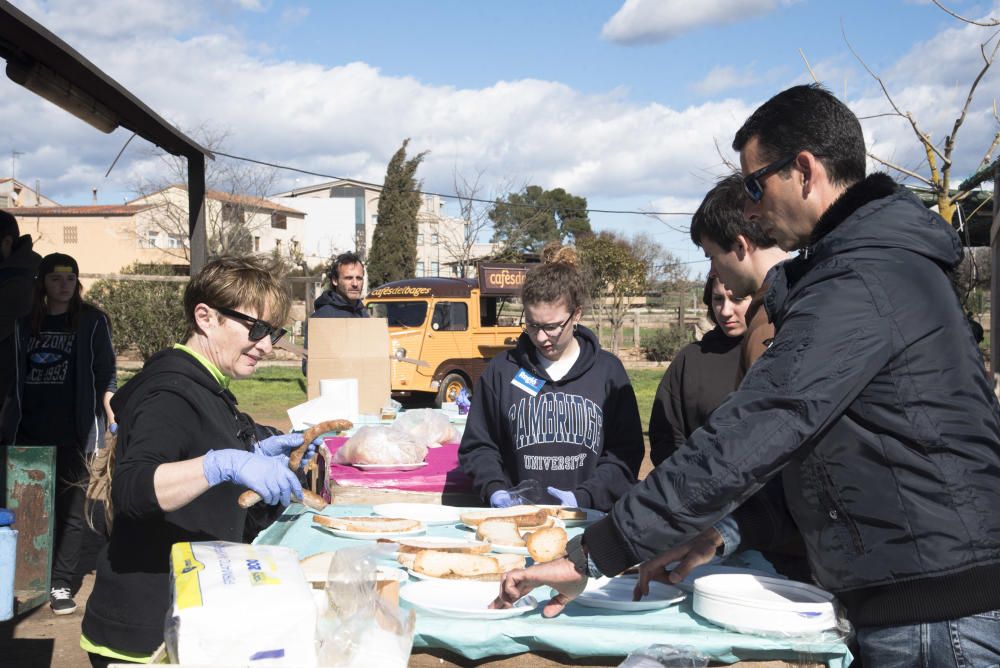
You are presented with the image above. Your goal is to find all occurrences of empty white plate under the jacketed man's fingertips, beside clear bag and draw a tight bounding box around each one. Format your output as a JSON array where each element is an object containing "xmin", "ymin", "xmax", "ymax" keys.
[{"xmin": 399, "ymin": 579, "xmax": 538, "ymax": 619}]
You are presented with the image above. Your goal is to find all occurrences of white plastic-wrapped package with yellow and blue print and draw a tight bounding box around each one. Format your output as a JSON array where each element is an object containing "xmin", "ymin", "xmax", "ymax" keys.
[{"xmin": 165, "ymin": 541, "xmax": 316, "ymax": 667}]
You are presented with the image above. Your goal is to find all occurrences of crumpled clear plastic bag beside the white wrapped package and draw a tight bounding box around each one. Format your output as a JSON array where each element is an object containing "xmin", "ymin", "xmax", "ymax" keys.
[{"xmin": 316, "ymin": 547, "xmax": 416, "ymax": 668}]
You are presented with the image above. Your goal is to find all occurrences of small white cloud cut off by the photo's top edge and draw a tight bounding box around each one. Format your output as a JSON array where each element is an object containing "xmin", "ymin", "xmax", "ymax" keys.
[{"xmin": 601, "ymin": 0, "xmax": 794, "ymax": 44}]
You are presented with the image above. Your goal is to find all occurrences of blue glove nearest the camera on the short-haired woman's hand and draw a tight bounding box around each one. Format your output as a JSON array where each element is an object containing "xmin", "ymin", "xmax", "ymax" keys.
[{"xmin": 202, "ymin": 449, "xmax": 302, "ymax": 506}]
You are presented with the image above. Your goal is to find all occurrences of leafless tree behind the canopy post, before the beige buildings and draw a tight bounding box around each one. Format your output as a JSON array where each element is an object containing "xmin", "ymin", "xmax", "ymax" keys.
[{"xmin": 132, "ymin": 127, "xmax": 282, "ymax": 264}]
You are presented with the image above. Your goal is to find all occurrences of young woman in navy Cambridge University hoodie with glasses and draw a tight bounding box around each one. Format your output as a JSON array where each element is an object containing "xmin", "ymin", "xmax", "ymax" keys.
[{"xmin": 459, "ymin": 248, "xmax": 644, "ymax": 511}]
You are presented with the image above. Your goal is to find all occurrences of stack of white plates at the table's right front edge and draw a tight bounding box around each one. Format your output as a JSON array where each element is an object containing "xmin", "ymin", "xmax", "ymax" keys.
[{"xmin": 693, "ymin": 574, "xmax": 837, "ymax": 636}]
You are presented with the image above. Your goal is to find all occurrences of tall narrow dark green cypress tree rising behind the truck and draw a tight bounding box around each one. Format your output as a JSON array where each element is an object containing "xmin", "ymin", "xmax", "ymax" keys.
[{"xmin": 366, "ymin": 139, "xmax": 427, "ymax": 288}]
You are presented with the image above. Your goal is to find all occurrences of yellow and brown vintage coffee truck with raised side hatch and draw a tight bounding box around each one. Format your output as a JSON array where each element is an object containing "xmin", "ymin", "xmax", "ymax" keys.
[{"xmin": 365, "ymin": 264, "xmax": 527, "ymax": 406}]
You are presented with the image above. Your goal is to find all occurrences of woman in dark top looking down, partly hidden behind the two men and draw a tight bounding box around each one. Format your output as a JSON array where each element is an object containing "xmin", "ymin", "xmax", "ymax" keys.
[{"xmin": 649, "ymin": 275, "xmax": 750, "ymax": 466}]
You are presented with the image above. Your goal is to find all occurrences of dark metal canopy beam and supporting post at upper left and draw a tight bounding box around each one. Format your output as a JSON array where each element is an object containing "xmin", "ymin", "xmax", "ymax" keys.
[{"xmin": 0, "ymin": 0, "xmax": 215, "ymax": 275}]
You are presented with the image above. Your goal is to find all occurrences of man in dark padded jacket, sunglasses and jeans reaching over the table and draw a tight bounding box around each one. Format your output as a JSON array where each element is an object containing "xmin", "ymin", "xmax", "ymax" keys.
[{"xmin": 497, "ymin": 86, "xmax": 1000, "ymax": 666}]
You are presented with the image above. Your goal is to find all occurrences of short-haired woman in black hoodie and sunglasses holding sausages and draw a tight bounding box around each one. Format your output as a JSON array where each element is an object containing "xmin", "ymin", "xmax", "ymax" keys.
[{"xmin": 80, "ymin": 258, "xmax": 315, "ymax": 666}]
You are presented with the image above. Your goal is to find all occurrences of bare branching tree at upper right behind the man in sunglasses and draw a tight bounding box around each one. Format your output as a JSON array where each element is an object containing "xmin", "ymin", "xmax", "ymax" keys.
[{"xmin": 844, "ymin": 5, "xmax": 1000, "ymax": 222}]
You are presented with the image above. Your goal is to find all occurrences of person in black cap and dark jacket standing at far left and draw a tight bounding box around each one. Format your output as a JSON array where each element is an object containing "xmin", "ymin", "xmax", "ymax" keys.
[{"xmin": 2, "ymin": 253, "xmax": 116, "ymax": 615}]
